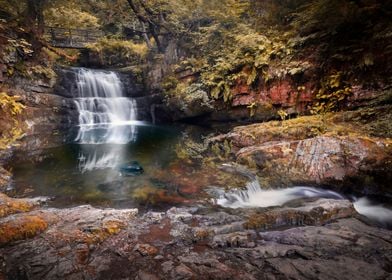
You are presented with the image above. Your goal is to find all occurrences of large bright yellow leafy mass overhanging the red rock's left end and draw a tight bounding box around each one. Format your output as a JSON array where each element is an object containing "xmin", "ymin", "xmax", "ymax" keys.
[{"xmin": 199, "ymin": 26, "xmax": 296, "ymax": 102}]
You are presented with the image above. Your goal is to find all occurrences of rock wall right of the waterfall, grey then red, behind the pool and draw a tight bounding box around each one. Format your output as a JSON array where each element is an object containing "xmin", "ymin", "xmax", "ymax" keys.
[{"xmin": 143, "ymin": 37, "xmax": 391, "ymax": 123}]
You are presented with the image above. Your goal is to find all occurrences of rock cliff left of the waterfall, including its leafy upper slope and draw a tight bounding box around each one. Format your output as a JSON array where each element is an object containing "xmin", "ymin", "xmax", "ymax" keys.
[{"xmin": 0, "ymin": 22, "xmax": 73, "ymax": 160}]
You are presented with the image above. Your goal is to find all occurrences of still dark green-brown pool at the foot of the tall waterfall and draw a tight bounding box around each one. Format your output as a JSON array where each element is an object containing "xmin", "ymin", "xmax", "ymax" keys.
[{"xmin": 9, "ymin": 123, "xmax": 208, "ymax": 208}]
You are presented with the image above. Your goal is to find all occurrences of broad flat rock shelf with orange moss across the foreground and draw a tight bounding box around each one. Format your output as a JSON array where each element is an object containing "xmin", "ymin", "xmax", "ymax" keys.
[{"xmin": 0, "ymin": 192, "xmax": 392, "ymax": 279}]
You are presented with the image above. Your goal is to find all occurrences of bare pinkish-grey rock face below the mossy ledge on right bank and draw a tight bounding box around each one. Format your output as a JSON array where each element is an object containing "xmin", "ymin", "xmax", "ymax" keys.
[{"xmin": 236, "ymin": 136, "xmax": 392, "ymax": 184}]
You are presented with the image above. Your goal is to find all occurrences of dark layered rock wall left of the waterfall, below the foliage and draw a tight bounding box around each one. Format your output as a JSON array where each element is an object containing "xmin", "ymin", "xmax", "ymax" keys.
[{"xmin": 1, "ymin": 70, "xmax": 69, "ymax": 163}]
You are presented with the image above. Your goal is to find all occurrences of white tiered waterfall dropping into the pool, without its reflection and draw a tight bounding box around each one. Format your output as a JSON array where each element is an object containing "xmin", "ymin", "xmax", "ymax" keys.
[{"xmin": 75, "ymin": 68, "xmax": 141, "ymax": 144}]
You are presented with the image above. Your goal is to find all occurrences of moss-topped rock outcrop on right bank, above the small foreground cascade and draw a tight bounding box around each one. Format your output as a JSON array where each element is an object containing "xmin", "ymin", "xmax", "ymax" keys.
[{"xmin": 209, "ymin": 105, "xmax": 392, "ymax": 195}]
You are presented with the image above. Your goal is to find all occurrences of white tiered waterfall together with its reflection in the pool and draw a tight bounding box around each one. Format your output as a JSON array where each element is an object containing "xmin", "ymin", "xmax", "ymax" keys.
[{"xmin": 75, "ymin": 68, "xmax": 144, "ymax": 173}]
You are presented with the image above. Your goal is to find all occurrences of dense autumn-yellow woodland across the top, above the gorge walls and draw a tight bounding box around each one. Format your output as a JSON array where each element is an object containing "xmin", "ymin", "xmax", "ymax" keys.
[{"xmin": 1, "ymin": 0, "xmax": 392, "ymax": 113}]
